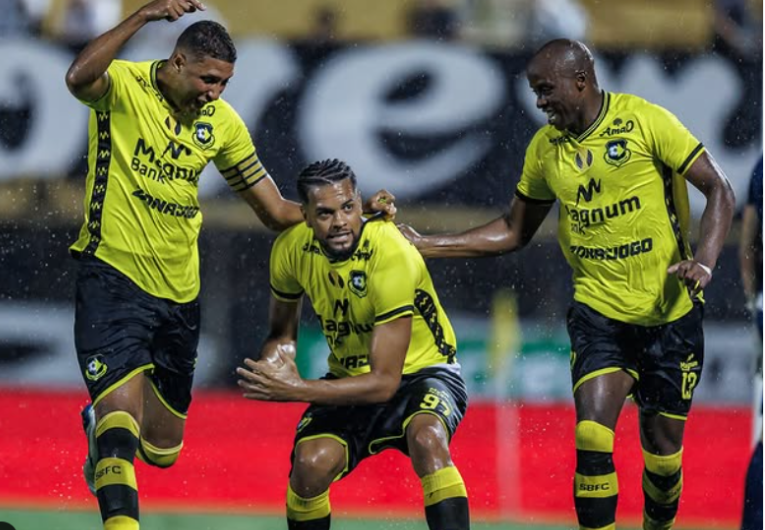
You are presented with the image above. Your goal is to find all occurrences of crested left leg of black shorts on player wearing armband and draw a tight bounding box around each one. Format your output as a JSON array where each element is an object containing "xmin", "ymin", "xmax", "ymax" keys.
[{"xmin": 74, "ymin": 259, "xmax": 156, "ymax": 405}]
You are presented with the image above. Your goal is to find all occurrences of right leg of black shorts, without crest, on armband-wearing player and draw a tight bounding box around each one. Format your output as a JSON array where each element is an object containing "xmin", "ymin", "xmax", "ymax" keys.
[{"xmin": 147, "ymin": 300, "xmax": 200, "ymax": 419}]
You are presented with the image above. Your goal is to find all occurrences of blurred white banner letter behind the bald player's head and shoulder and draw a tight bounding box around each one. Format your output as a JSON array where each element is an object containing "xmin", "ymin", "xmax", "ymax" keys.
[{"xmin": 516, "ymin": 54, "xmax": 761, "ymax": 211}]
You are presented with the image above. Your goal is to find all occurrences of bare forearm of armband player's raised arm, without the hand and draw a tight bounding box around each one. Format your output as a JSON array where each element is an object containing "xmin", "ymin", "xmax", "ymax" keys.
[{"xmin": 66, "ymin": 11, "xmax": 147, "ymax": 91}]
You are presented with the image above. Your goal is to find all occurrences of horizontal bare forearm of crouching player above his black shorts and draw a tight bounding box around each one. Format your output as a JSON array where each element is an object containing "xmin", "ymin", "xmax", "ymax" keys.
[{"xmin": 295, "ymin": 373, "xmax": 401, "ymax": 405}]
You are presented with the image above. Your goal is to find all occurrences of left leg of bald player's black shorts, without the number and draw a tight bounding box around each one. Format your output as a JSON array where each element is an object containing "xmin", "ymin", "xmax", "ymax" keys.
[{"xmin": 566, "ymin": 302, "xmax": 638, "ymax": 394}]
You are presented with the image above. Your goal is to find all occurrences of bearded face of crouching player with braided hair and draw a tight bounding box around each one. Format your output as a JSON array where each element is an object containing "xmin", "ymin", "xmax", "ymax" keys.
[{"xmin": 302, "ymin": 178, "xmax": 362, "ymax": 260}]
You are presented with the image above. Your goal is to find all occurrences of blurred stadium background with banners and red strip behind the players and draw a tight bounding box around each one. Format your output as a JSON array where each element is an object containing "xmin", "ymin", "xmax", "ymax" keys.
[{"xmin": 0, "ymin": 0, "xmax": 762, "ymax": 530}]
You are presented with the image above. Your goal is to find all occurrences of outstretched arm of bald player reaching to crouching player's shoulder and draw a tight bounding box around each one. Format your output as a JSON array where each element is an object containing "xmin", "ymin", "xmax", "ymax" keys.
[{"xmin": 399, "ymin": 197, "xmax": 553, "ymax": 258}]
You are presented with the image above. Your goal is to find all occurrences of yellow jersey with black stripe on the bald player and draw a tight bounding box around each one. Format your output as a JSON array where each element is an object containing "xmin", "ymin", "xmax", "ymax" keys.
[{"xmin": 516, "ymin": 92, "xmax": 704, "ymax": 326}]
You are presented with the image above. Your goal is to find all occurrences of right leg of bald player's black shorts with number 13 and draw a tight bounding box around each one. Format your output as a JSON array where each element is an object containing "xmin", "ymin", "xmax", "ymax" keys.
[{"xmin": 635, "ymin": 304, "xmax": 704, "ymax": 420}]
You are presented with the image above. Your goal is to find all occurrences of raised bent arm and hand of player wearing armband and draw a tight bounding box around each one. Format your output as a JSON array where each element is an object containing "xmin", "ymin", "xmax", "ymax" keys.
[{"xmin": 66, "ymin": 0, "xmax": 205, "ymax": 101}]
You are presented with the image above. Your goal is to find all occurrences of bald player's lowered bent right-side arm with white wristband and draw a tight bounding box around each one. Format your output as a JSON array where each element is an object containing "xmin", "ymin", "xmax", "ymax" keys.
[{"xmin": 667, "ymin": 152, "xmax": 736, "ymax": 292}]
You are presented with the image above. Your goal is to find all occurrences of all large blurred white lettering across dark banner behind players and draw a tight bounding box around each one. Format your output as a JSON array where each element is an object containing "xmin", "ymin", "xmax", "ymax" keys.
[{"xmin": 0, "ymin": 39, "xmax": 760, "ymax": 216}]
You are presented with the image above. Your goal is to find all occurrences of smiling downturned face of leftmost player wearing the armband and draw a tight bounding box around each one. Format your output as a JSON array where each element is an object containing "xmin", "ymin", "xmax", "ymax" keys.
[{"xmin": 165, "ymin": 51, "xmax": 234, "ymax": 118}]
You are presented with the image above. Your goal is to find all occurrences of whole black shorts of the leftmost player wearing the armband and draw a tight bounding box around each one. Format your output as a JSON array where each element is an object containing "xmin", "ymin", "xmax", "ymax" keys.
[{"xmin": 74, "ymin": 257, "xmax": 200, "ymax": 417}]
